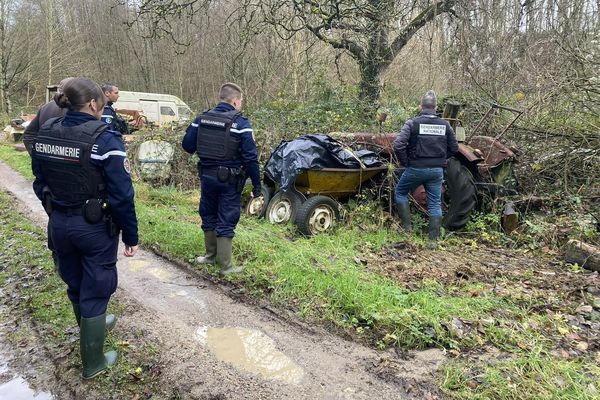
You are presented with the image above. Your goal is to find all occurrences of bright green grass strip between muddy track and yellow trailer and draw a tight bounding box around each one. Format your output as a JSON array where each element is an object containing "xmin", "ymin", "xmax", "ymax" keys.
[{"xmin": 136, "ymin": 184, "xmax": 526, "ymax": 348}]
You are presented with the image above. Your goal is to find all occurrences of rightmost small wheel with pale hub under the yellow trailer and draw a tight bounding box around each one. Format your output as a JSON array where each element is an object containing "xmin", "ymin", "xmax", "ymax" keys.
[{"xmin": 296, "ymin": 196, "xmax": 340, "ymax": 236}]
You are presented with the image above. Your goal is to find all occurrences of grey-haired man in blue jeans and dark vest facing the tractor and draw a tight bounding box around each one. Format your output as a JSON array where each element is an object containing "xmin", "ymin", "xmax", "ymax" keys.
[{"xmin": 394, "ymin": 90, "xmax": 458, "ymax": 245}]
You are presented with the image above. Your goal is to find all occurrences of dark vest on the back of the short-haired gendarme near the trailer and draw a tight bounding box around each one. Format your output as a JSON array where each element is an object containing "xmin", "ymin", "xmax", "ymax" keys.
[{"xmin": 196, "ymin": 110, "xmax": 241, "ymax": 160}]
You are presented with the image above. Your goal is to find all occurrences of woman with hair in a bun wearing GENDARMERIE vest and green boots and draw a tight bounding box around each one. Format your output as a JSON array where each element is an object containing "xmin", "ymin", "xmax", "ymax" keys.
[{"xmin": 31, "ymin": 78, "xmax": 138, "ymax": 379}]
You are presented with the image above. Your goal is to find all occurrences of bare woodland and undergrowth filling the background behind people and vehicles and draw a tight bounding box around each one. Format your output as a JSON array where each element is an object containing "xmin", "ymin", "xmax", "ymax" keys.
[{"xmin": 0, "ymin": 0, "xmax": 600, "ymax": 204}]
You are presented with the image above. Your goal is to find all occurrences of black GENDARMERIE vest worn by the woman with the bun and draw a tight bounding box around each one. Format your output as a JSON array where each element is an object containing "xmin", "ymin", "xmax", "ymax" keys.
[{"xmin": 31, "ymin": 118, "xmax": 108, "ymax": 203}]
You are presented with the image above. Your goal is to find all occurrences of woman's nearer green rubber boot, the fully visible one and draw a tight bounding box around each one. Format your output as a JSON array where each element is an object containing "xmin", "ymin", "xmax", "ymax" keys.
[{"xmin": 80, "ymin": 314, "xmax": 117, "ymax": 379}]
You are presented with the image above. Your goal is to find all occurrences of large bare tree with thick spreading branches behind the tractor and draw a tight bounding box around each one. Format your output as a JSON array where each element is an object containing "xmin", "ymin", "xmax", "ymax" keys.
[{"xmin": 234, "ymin": 0, "xmax": 457, "ymax": 111}]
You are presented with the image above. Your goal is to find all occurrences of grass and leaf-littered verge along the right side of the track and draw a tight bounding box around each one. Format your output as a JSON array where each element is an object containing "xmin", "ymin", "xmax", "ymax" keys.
[{"xmin": 2, "ymin": 142, "xmax": 600, "ymax": 399}]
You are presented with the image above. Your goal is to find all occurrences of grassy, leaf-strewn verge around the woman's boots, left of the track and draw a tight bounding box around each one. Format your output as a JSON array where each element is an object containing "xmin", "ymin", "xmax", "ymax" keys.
[{"xmin": 0, "ymin": 191, "xmax": 162, "ymax": 399}]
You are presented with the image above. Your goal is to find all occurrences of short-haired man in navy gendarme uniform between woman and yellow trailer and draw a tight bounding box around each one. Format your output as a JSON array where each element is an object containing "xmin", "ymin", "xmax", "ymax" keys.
[{"xmin": 182, "ymin": 83, "xmax": 261, "ymax": 275}]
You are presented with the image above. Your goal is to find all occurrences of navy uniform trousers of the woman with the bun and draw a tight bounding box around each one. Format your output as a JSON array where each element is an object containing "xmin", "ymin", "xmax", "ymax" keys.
[{"xmin": 50, "ymin": 211, "xmax": 119, "ymax": 318}]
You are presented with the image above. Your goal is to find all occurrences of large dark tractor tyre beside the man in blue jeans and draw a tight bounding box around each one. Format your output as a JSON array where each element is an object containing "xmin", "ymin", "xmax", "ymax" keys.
[{"xmin": 443, "ymin": 157, "xmax": 477, "ymax": 231}]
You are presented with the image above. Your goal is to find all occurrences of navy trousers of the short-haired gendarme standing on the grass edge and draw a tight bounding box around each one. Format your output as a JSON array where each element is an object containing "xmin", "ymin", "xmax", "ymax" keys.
[{"xmin": 198, "ymin": 173, "xmax": 242, "ymax": 238}]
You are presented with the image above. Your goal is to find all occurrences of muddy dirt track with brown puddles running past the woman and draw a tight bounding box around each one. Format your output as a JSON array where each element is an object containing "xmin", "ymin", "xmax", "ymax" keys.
[{"xmin": 0, "ymin": 162, "xmax": 443, "ymax": 399}]
